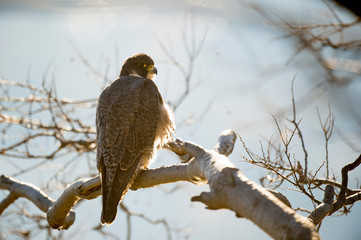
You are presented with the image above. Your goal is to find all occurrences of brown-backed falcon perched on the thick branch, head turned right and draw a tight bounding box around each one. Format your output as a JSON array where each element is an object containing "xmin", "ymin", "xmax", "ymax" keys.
[{"xmin": 96, "ymin": 53, "xmax": 175, "ymax": 225}]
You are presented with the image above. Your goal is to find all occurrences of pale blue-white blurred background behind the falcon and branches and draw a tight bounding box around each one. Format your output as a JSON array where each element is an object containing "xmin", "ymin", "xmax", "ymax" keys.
[{"xmin": 0, "ymin": 0, "xmax": 361, "ymax": 240}]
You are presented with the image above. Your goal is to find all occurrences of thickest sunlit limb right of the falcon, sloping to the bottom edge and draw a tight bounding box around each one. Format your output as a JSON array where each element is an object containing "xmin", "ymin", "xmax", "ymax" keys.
[{"xmin": 137, "ymin": 130, "xmax": 319, "ymax": 239}]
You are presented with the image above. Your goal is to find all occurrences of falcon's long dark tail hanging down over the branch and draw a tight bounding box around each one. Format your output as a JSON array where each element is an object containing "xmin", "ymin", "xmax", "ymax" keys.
[{"xmin": 101, "ymin": 157, "xmax": 140, "ymax": 225}]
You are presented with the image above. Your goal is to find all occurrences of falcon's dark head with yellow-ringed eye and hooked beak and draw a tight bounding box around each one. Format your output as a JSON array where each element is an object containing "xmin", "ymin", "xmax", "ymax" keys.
[{"xmin": 120, "ymin": 53, "xmax": 158, "ymax": 80}]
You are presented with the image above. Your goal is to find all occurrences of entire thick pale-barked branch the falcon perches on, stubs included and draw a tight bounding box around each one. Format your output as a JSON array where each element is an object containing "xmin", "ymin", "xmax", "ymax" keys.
[{"xmin": 0, "ymin": 130, "xmax": 319, "ymax": 239}]
